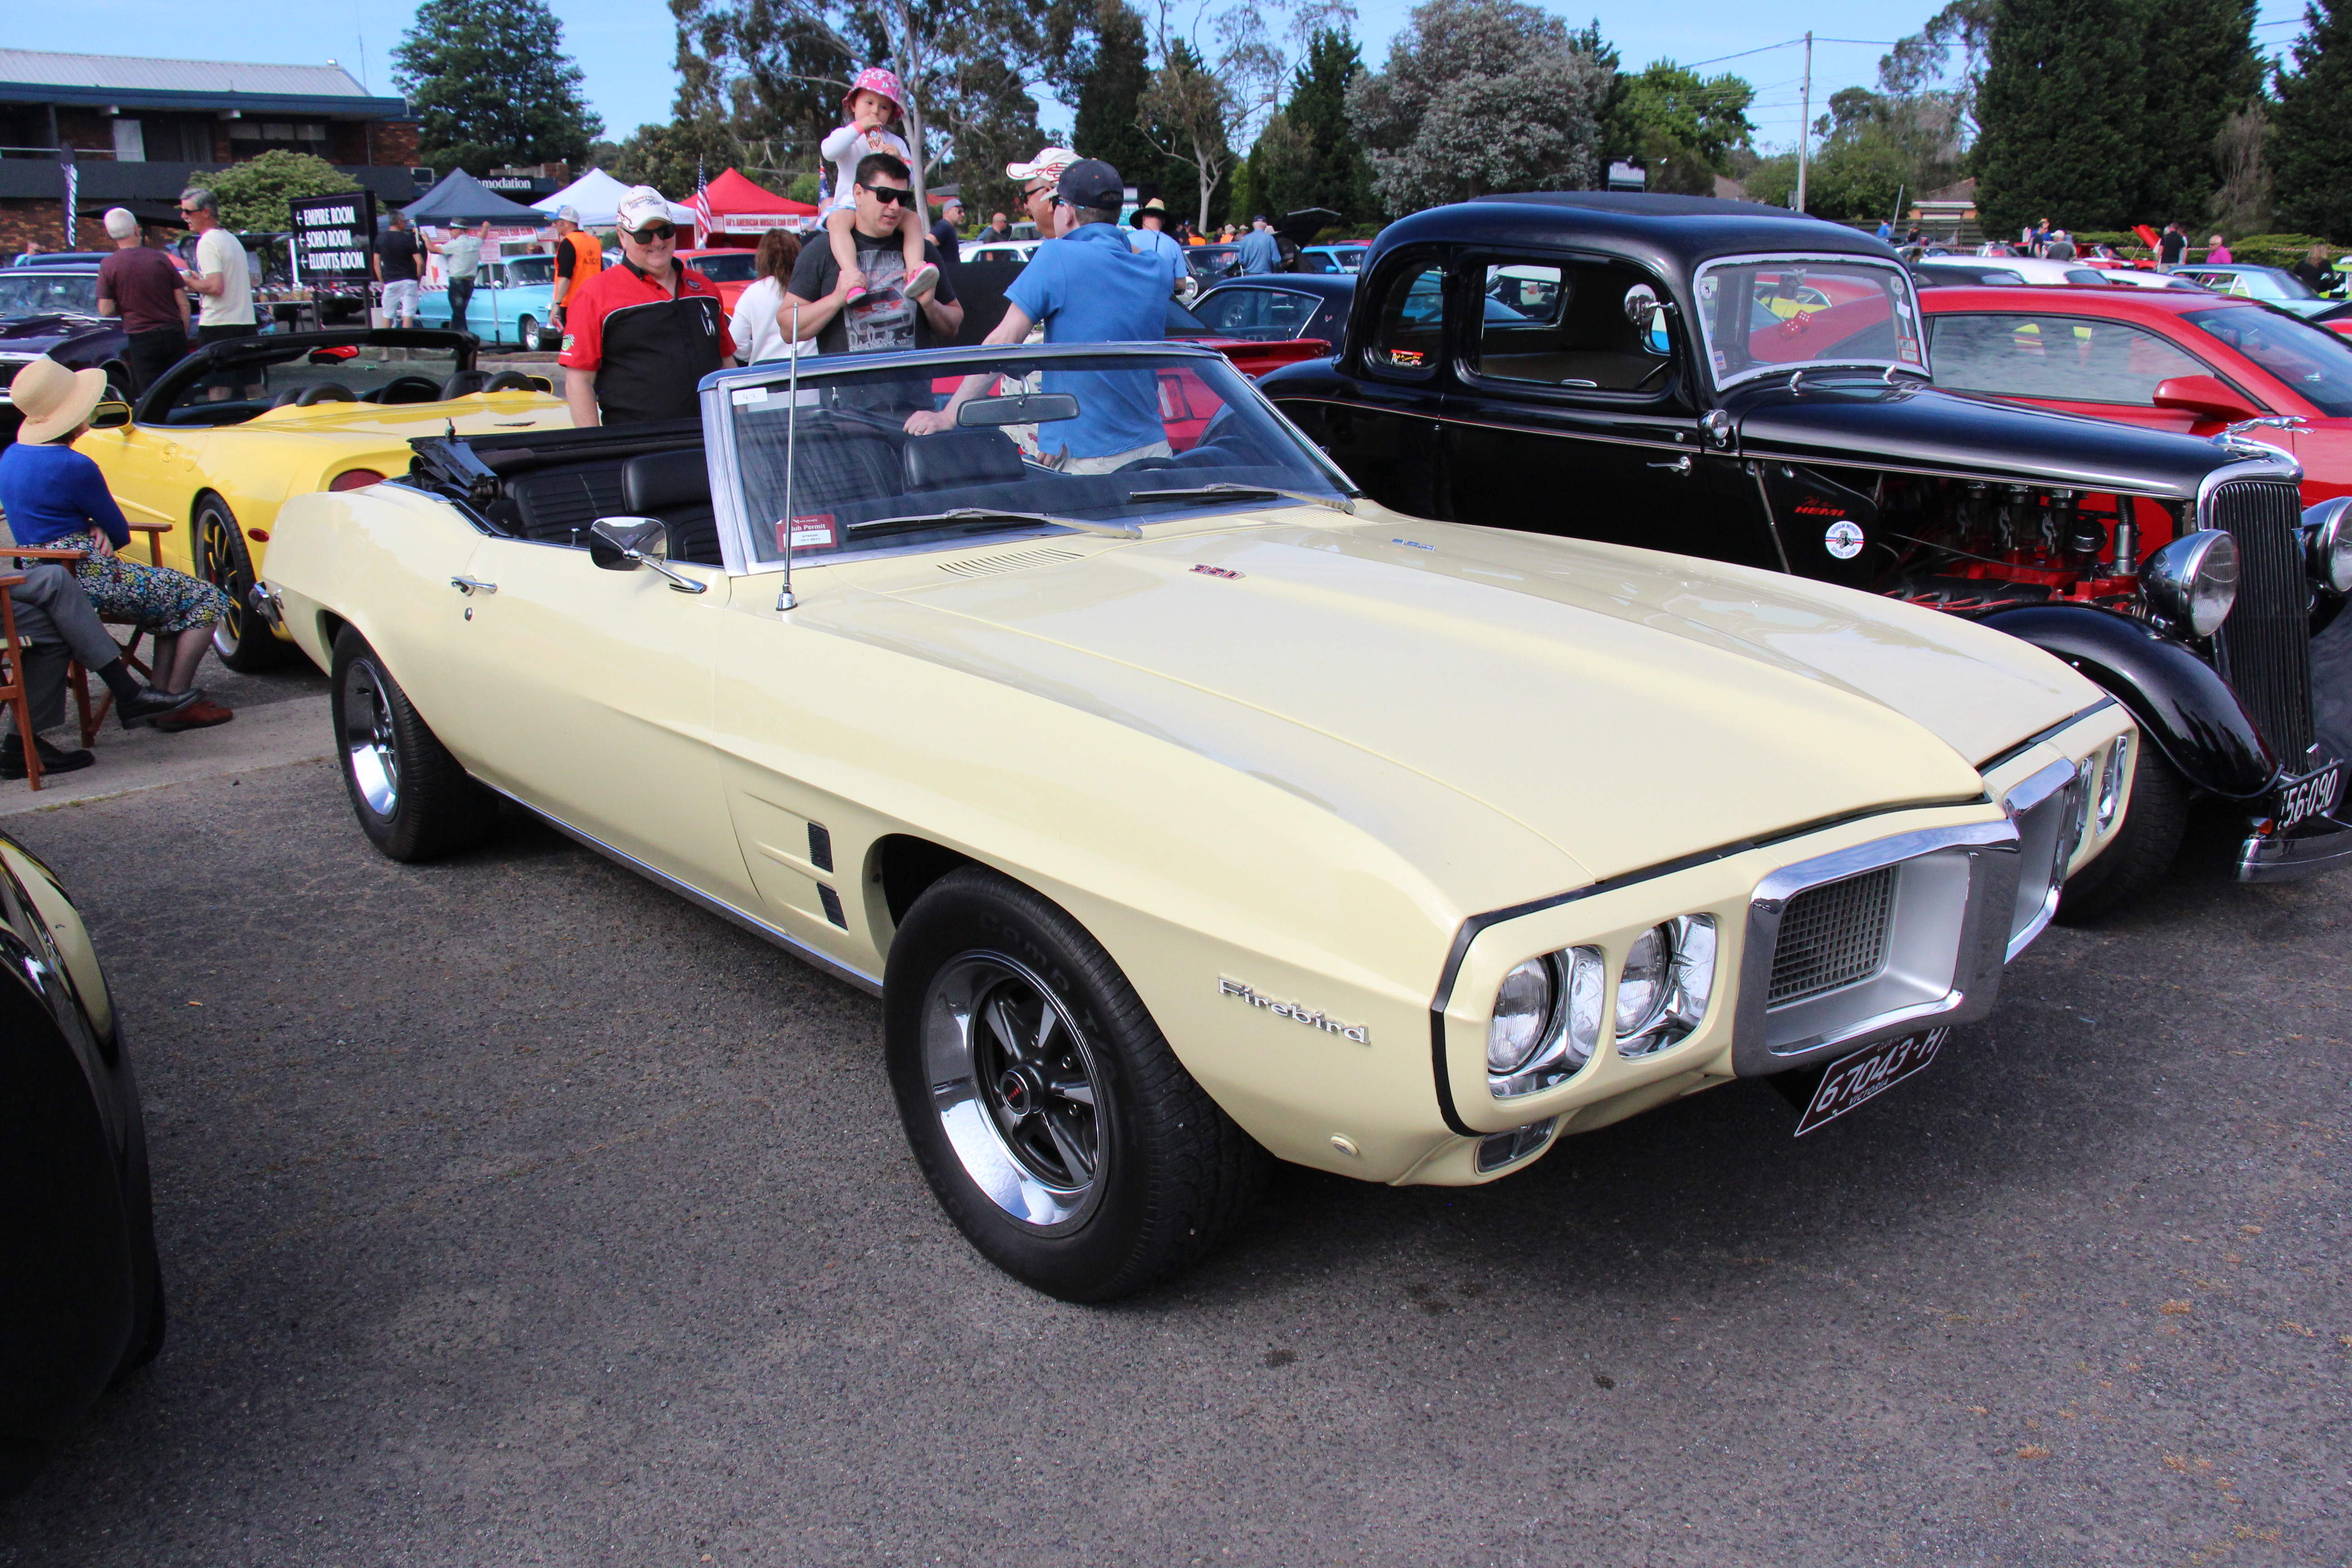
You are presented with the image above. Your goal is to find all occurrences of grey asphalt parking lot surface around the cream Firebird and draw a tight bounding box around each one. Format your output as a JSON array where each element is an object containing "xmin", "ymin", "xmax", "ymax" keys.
[{"xmin": 0, "ymin": 677, "xmax": 2352, "ymax": 1568}]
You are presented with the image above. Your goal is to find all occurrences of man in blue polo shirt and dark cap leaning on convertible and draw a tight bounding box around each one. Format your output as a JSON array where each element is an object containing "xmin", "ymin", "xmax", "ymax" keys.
[{"xmin": 906, "ymin": 157, "xmax": 1171, "ymax": 472}]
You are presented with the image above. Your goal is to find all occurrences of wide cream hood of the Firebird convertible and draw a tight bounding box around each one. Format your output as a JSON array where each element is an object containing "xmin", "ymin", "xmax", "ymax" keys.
[{"xmin": 840, "ymin": 508, "xmax": 2098, "ymax": 877}]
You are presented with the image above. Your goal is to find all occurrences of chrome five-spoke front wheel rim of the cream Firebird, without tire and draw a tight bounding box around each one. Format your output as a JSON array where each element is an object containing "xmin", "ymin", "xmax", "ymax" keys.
[{"xmin": 922, "ymin": 952, "xmax": 1108, "ymax": 1227}]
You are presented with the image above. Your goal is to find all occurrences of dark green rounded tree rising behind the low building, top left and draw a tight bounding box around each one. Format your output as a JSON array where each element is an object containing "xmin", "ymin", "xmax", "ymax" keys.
[{"xmin": 393, "ymin": 0, "xmax": 604, "ymax": 174}]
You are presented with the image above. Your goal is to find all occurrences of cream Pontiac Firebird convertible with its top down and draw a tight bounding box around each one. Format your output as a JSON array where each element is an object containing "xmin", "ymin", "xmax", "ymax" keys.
[{"xmin": 261, "ymin": 343, "xmax": 2136, "ymax": 1300}]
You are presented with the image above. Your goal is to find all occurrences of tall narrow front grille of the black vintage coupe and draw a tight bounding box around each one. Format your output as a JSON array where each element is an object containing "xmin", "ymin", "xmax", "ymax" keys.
[{"xmin": 2204, "ymin": 480, "xmax": 2312, "ymax": 771}]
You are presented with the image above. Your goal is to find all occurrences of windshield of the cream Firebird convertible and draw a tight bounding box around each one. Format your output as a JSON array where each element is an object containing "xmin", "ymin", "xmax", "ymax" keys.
[{"xmin": 722, "ymin": 348, "xmax": 1355, "ymax": 562}]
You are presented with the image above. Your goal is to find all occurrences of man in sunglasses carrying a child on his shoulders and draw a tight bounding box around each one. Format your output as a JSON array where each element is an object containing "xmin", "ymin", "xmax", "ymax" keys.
[{"xmin": 776, "ymin": 153, "xmax": 964, "ymax": 385}]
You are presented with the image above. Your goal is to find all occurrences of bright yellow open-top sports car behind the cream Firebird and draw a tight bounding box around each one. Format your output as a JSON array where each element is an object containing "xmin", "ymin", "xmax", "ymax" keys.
[{"xmin": 75, "ymin": 329, "xmax": 572, "ymax": 670}]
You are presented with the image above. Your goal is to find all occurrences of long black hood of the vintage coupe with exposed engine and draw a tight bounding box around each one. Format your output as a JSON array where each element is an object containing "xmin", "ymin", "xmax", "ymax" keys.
[{"xmin": 1724, "ymin": 372, "xmax": 2239, "ymax": 498}]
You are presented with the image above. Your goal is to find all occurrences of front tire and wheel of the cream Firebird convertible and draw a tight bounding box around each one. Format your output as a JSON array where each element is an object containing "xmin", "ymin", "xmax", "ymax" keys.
[{"xmin": 882, "ymin": 867, "xmax": 1268, "ymax": 1303}]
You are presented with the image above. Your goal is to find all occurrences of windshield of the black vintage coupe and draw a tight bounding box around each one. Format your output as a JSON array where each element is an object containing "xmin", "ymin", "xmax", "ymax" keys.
[{"xmin": 1698, "ymin": 256, "xmax": 1926, "ymax": 388}]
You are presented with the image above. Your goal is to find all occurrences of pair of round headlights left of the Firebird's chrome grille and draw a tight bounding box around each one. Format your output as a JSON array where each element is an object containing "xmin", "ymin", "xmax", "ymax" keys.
[{"xmin": 1486, "ymin": 915, "xmax": 1715, "ymax": 1100}]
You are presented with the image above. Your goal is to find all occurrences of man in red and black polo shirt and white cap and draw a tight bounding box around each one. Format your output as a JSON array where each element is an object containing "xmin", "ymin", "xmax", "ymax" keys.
[{"xmin": 555, "ymin": 186, "xmax": 734, "ymax": 426}]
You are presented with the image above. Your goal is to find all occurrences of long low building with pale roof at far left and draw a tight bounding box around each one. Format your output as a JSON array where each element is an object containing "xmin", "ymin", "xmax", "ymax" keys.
[{"xmin": 0, "ymin": 49, "xmax": 416, "ymax": 254}]
